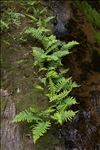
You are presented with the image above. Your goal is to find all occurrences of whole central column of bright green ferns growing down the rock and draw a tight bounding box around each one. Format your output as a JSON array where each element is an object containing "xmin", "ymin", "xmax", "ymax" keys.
[{"xmin": 13, "ymin": 1, "xmax": 78, "ymax": 143}]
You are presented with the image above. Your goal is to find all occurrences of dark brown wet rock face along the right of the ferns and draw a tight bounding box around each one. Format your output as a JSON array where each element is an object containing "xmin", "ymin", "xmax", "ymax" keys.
[{"xmin": 50, "ymin": 0, "xmax": 100, "ymax": 150}]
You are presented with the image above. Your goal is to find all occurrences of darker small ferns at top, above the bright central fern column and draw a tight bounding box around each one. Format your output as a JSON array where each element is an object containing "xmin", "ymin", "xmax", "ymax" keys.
[{"xmin": 25, "ymin": 0, "xmax": 54, "ymax": 28}]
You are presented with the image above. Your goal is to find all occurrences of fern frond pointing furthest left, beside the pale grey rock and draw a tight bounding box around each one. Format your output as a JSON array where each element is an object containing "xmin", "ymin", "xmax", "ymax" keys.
[{"xmin": 13, "ymin": 110, "xmax": 41, "ymax": 122}]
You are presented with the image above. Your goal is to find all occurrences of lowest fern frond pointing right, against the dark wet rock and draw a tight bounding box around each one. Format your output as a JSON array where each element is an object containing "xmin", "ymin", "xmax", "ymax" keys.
[{"xmin": 52, "ymin": 110, "xmax": 76, "ymax": 124}]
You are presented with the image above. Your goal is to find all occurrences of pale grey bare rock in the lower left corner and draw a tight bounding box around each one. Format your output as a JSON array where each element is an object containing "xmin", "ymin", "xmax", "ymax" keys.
[{"xmin": 1, "ymin": 97, "xmax": 23, "ymax": 150}]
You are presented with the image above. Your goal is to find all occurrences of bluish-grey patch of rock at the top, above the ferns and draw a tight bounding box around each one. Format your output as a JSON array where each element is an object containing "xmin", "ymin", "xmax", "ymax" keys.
[{"xmin": 49, "ymin": 0, "xmax": 72, "ymax": 38}]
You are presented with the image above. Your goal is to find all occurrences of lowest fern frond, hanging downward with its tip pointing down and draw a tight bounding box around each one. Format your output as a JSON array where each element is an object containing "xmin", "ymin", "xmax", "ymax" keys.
[{"xmin": 32, "ymin": 121, "xmax": 51, "ymax": 143}]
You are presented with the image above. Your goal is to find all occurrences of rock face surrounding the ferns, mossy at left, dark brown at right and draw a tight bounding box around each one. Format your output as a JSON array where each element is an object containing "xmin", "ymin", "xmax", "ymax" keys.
[{"xmin": 1, "ymin": 0, "xmax": 100, "ymax": 150}]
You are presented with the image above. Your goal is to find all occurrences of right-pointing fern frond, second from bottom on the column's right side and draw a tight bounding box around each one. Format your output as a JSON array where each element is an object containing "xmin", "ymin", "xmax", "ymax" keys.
[{"xmin": 57, "ymin": 97, "xmax": 77, "ymax": 111}]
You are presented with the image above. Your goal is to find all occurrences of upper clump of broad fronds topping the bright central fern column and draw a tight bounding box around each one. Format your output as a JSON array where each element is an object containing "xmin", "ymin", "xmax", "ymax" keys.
[{"xmin": 24, "ymin": 27, "xmax": 78, "ymax": 68}]
